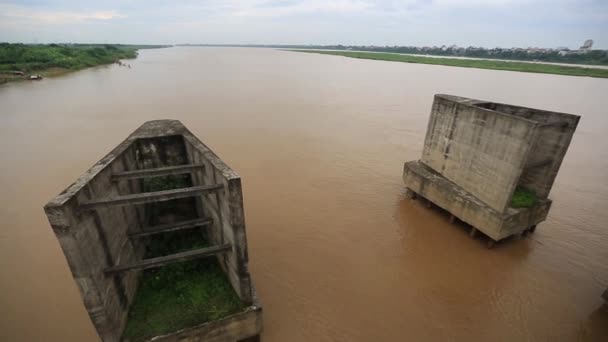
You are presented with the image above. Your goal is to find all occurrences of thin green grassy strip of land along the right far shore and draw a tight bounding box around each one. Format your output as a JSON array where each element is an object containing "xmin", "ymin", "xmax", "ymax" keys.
[{"xmin": 287, "ymin": 50, "xmax": 608, "ymax": 78}]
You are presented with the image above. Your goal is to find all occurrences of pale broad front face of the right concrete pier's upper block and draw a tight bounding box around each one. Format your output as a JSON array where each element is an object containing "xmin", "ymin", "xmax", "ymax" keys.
[{"xmin": 421, "ymin": 95, "xmax": 537, "ymax": 212}]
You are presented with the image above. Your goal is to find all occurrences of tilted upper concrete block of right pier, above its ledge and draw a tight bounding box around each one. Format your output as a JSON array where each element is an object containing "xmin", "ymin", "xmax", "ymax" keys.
[{"xmin": 421, "ymin": 95, "xmax": 579, "ymax": 213}]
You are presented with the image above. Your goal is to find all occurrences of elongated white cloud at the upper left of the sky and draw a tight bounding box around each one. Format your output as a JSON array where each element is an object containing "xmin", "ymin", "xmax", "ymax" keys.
[{"xmin": 0, "ymin": 4, "xmax": 127, "ymax": 24}]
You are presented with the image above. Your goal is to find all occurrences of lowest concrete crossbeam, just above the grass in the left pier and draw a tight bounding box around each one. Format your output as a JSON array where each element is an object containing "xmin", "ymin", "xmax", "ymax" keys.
[{"xmin": 104, "ymin": 244, "xmax": 232, "ymax": 274}]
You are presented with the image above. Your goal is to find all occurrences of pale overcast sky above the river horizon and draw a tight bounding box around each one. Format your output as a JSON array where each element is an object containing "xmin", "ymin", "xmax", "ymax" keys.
[{"xmin": 0, "ymin": 0, "xmax": 608, "ymax": 49}]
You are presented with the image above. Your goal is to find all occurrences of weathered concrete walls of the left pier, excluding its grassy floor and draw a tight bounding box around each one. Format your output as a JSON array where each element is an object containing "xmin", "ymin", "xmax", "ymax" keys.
[{"xmin": 44, "ymin": 120, "xmax": 261, "ymax": 341}]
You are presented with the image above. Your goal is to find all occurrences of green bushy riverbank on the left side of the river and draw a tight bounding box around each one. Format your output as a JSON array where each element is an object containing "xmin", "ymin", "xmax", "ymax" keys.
[{"xmin": 0, "ymin": 43, "xmax": 164, "ymax": 84}]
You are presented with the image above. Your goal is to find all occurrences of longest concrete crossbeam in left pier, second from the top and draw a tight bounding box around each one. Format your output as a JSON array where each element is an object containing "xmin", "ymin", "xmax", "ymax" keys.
[{"xmin": 80, "ymin": 184, "xmax": 224, "ymax": 209}]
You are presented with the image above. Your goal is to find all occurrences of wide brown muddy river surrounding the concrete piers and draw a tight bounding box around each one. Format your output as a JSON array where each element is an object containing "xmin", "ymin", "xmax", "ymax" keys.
[{"xmin": 0, "ymin": 48, "xmax": 608, "ymax": 342}]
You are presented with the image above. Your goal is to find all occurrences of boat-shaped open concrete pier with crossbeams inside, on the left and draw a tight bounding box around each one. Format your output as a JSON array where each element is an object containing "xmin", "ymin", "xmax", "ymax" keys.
[{"xmin": 44, "ymin": 120, "xmax": 262, "ymax": 342}]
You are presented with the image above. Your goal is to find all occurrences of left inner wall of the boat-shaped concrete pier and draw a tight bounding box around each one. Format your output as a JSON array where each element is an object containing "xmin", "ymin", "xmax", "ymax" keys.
[{"xmin": 45, "ymin": 140, "xmax": 144, "ymax": 341}]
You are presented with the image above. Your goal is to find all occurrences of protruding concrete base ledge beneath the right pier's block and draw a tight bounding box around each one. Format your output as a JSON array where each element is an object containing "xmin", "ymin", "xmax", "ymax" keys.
[{"xmin": 403, "ymin": 161, "xmax": 551, "ymax": 241}]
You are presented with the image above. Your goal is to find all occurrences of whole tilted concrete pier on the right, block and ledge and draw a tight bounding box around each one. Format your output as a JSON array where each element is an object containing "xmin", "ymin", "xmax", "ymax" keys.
[{"xmin": 403, "ymin": 95, "xmax": 580, "ymax": 240}]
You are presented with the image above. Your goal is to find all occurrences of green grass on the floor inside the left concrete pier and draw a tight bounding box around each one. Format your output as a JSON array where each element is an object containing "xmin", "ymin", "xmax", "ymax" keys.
[{"xmin": 123, "ymin": 220, "xmax": 244, "ymax": 342}]
